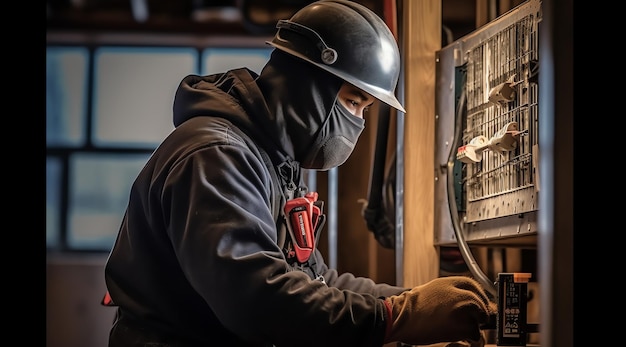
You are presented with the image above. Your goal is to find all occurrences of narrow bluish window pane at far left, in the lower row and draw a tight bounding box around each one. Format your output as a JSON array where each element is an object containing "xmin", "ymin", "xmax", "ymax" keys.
[{"xmin": 46, "ymin": 158, "xmax": 62, "ymax": 248}]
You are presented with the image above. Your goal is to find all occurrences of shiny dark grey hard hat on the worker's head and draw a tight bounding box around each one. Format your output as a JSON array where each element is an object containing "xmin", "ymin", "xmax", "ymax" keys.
[{"xmin": 267, "ymin": 0, "xmax": 405, "ymax": 112}]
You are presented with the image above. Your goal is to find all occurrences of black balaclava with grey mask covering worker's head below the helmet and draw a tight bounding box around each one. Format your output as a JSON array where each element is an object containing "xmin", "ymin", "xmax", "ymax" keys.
[{"xmin": 257, "ymin": 50, "xmax": 365, "ymax": 171}]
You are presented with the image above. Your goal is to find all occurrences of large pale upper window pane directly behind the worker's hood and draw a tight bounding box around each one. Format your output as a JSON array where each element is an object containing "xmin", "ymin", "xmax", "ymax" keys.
[{"xmin": 93, "ymin": 47, "xmax": 199, "ymax": 147}]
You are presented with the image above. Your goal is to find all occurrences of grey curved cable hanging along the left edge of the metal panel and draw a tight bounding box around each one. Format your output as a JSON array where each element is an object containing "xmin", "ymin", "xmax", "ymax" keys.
[{"xmin": 446, "ymin": 84, "xmax": 498, "ymax": 298}]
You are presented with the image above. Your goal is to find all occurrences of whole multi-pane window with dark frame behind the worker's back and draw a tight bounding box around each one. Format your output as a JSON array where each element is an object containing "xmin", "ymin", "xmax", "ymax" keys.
[{"xmin": 46, "ymin": 45, "xmax": 271, "ymax": 252}]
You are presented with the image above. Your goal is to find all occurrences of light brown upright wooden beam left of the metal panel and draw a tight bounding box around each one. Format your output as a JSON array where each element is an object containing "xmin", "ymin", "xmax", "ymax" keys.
[{"xmin": 399, "ymin": 0, "xmax": 441, "ymax": 287}]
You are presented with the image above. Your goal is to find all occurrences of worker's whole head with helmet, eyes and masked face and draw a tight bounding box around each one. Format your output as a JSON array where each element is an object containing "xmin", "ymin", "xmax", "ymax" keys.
[{"xmin": 258, "ymin": 0, "xmax": 404, "ymax": 170}]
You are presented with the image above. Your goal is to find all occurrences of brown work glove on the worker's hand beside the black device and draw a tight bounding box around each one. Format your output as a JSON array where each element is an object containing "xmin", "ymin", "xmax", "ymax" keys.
[{"xmin": 385, "ymin": 276, "xmax": 497, "ymax": 345}]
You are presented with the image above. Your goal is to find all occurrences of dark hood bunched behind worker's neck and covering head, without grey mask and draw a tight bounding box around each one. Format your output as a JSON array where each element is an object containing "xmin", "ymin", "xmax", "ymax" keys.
[{"xmin": 173, "ymin": 50, "xmax": 343, "ymax": 166}]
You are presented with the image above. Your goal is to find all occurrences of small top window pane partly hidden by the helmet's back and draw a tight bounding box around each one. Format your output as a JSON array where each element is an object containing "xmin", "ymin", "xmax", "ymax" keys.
[{"xmin": 202, "ymin": 48, "xmax": 273, "ymax": 75}]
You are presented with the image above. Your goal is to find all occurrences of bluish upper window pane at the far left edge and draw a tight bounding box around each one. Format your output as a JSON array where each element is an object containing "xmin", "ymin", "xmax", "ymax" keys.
[{"xmin": 46, "ymin": 47, "xmax": 89, "ymax": 146}]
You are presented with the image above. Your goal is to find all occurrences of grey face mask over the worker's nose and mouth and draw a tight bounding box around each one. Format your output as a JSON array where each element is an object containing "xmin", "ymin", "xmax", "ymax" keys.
[{"xmin": 301, "ymin": 101, "xmax": 365, "ymax": 171}]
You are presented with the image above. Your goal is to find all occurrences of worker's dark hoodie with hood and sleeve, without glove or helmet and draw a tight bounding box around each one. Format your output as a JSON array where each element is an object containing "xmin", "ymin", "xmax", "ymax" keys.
[{"xmin": 105, "ymin": 52, "xmax": 405, "ymax": 347}]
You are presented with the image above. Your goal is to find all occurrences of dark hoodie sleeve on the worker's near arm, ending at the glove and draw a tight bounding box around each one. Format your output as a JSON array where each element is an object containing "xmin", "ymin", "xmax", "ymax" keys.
[{"xmin": 162, "ymin": 123, "xmax": 394, "ymax": 347}]
